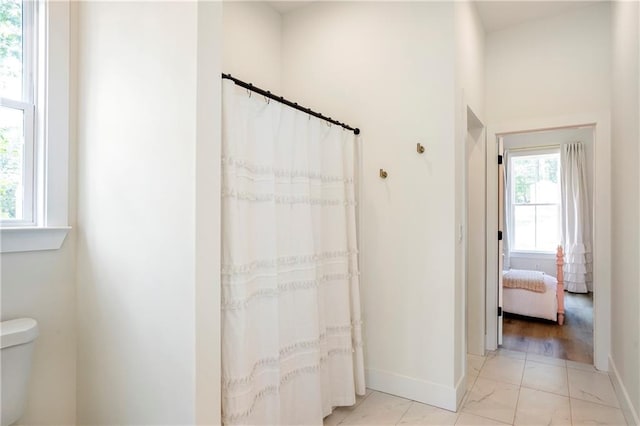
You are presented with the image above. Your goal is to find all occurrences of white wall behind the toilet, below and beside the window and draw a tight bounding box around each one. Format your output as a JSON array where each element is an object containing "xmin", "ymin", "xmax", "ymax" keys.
[{"xmin": 0, "ymin": 2, "xmax": 76, "ymax": 425}]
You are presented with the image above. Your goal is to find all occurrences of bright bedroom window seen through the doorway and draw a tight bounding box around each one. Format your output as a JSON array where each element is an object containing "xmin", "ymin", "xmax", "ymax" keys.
[{"xmin": 509, "ymin": 150, "xmax": 560, "ymax": 253}]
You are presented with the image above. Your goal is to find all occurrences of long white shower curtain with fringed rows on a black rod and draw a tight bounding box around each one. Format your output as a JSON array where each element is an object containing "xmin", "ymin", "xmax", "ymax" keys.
[{"xmin": 222, "ymin": 80, "xmax": 365, "ymax": 425}]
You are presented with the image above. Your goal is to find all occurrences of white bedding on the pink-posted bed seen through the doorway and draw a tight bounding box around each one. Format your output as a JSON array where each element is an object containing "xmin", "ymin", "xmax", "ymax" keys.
[{"xmin": 502, "ymin": 275, "xmax": 558, "ymax": 321}]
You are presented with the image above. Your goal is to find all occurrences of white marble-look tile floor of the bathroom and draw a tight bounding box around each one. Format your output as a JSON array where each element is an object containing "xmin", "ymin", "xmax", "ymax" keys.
[{"xmin": 324, "ymin": 350, "xmax": 626, "ymax": 426}]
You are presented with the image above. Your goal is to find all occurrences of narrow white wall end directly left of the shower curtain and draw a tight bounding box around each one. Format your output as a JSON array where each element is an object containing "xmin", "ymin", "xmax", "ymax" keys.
[{"xmin": 194, "ymin": 2, "xmax": 222, "ymax": 425}]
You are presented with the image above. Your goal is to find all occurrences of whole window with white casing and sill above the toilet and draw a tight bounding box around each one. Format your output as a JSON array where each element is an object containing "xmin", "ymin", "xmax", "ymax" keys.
[{"xmin": 0, "ymin": 0, "xmax": 70, "ymax": 253}]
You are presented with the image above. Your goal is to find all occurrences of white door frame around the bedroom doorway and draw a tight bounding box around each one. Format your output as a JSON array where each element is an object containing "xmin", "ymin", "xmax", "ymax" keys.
[{"xmin": 486, "ymin": 111, "xmax": 611, "ymax": 371}]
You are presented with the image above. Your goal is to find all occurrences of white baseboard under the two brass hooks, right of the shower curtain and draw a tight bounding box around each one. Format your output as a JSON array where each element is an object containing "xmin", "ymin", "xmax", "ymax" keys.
[{"xmin": 365, "ymin": 369, "xmax": 466, "ymax": 411}]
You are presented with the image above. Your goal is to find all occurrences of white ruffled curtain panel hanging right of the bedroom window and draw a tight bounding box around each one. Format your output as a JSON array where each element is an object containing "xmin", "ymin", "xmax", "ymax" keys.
[{"xmin": 560, "ymin": 142, "xmax": 593, "ymax": 293}]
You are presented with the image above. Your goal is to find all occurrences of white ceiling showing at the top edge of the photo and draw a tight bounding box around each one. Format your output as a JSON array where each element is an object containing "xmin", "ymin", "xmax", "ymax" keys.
[{"xmin": 267, "ymin": 0, "xmax": 594, "ymax": 32}]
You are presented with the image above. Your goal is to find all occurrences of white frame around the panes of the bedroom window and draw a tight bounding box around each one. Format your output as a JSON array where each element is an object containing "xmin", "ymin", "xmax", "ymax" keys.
[{"xmin": 508, "ymin": 145, "xmax": 562, "ymax": 253}]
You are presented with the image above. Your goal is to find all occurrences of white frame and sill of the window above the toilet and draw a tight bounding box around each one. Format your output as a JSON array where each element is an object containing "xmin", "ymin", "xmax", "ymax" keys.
[{"xmin": 0, "ymin": 0, "xmax": 71, "ymax": 253}]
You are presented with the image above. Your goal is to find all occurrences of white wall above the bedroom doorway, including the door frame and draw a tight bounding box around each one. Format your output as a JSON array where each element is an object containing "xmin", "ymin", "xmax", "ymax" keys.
[{"xmin": 485, "ymin": 2, "xmax": 611, "ymax": 370}]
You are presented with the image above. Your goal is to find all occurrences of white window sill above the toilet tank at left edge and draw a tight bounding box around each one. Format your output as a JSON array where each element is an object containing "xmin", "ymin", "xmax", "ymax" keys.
[{"xmin": 0, "ymin": 226, "xmax": 71, "ymax": 253}]
